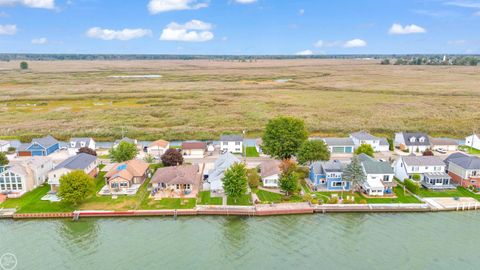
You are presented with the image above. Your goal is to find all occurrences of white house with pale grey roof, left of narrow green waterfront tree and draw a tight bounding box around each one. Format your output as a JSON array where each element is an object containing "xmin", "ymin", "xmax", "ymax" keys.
[{"xmin": 203, "ymin": 152, "xmax": 240, "ymax": 193}]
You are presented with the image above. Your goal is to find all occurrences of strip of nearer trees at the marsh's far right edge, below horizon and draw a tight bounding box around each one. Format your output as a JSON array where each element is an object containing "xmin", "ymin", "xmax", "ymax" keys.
[{"xmin": 381, "ymin": 55, "xmax": 480, "ymax": 66}]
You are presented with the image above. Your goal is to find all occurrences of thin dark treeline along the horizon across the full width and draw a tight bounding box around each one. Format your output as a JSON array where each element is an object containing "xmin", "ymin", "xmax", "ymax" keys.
[{"xmin": 0, "ymin": 53, "xmax": 480, "ymax": 61}]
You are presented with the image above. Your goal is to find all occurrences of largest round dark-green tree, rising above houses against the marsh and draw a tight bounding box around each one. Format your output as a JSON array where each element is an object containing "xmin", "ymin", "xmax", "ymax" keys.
[{"xmin": 262, "ymin": 116, "xmax": 308, "ymax": 159}]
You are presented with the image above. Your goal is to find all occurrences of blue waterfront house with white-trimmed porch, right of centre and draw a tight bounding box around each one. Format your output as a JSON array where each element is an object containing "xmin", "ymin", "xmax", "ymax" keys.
[{"xmin": 309, "ymin": 160, "xmax": 351, "ymax": 191}]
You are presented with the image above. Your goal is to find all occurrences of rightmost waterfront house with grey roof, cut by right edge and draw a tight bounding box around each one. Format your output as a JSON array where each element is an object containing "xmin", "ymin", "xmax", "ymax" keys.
[{"xmin": 445, "ymin": 153, "xmax": 480, "ymax": 189}]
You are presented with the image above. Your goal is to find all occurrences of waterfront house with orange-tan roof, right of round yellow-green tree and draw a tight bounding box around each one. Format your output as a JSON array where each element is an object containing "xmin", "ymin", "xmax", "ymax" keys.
[{"xmin": 101, "ymin": 159, "xmax": 149, "ymax": 194}]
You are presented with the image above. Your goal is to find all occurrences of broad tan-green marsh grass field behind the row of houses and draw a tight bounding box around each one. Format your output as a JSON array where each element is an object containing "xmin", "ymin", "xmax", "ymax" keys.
[{"xmin": 0, "ymin": 59, "xmax": 480, "ymax": 140}]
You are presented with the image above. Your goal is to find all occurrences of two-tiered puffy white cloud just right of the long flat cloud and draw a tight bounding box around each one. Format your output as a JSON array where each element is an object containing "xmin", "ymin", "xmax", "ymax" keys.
[{"xmin": 160, "ymin": 20, "xmax": 214, "ymax": 42}]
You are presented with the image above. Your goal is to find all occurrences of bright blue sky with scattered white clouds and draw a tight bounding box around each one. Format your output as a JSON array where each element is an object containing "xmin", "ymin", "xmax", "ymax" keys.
[{"xmin": 0, "ymin": 0, "xmax": 480, "ymax": 55}]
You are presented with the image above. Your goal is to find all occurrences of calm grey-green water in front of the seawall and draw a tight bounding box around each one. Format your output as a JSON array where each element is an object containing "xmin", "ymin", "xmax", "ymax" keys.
[{"xmin": 0, "ymin": 212, "xmax": 480, "ymax": 269}]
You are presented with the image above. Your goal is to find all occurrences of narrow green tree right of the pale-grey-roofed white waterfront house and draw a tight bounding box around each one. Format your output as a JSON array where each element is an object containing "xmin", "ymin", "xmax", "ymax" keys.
[{"xmin": 223, "ymin": 163, "xmax": 247, "ymax": 203}]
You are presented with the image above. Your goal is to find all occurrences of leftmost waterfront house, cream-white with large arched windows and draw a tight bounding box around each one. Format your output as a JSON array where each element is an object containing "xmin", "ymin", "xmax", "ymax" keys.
[{"xmin": 0, "ymin": 156, "xmax": 53, "ymax": 198}]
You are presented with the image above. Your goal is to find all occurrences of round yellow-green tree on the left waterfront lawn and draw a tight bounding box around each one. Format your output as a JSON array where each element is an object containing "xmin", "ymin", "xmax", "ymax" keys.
[{"xmin": 58, "ymin": 171, "xmax": 94, "ymax": 205}]
